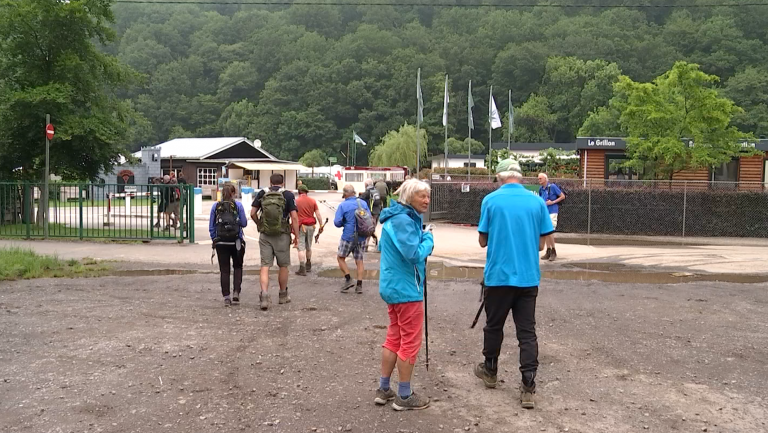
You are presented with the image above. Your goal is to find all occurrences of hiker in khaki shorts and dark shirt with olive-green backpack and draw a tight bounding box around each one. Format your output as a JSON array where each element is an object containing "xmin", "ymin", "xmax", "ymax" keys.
[{"xmin": 251, "ymin": 174, "xmax": 299, "ymax": 310}]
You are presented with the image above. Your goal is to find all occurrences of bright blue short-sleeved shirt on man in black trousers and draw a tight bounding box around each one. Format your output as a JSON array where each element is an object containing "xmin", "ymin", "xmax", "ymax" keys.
[{"xmin": 477, "ymin": 183, "xmax": 555, "ymax": 288}]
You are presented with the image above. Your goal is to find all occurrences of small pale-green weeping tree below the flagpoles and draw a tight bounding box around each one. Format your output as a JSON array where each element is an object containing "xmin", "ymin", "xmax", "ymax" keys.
[{"xmin": 368, "ymin": 124, "xmax": 427, "ymax": 167}]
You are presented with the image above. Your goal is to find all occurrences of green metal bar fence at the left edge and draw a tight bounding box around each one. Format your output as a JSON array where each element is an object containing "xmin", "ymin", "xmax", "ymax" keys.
[{"xmin": 0, "ymin": 182, "xmax": 195, "ymax": 242}]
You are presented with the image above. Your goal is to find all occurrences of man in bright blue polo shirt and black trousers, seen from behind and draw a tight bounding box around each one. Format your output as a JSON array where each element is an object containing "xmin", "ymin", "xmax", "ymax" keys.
[{"xmin": 475, "ymin": 159, "xmax": 555, "ymax": 409}]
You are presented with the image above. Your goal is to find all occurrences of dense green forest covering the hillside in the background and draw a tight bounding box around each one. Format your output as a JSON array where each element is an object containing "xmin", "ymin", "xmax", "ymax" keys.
[{"xmin": 109, "ymin": 0, "xmax": 768, "ymax": 164}]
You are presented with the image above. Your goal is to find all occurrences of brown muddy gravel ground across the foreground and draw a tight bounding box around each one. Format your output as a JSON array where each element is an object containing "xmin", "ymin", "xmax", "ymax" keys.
[{"xmin": 0, "ymin": 264, "xmax": 768, "ymax": 433}]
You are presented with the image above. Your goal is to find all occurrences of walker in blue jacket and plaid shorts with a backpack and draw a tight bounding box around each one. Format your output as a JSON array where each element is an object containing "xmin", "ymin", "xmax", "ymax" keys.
[{"xmin": 333, "ymin": 184, "xmax": 370, "ymax": 294}]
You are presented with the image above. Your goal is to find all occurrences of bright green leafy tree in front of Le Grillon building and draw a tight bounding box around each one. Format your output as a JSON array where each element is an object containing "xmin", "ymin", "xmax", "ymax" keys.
[{"xmin": 615, "ymin": 62, "xmax": 749, "ymax": 180}]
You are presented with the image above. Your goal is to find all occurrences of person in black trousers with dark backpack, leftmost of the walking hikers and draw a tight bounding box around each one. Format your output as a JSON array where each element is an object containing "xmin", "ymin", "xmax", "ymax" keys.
[{"xmin": 208, "ymin": 184, "xmax": 248, "ymax": 307}]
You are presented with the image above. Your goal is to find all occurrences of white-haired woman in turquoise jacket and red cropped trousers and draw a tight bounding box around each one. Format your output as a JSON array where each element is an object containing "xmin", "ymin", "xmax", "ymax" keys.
[{"xmin": 374, "ymin": 179, "xmax": 434, "ymax": 410}]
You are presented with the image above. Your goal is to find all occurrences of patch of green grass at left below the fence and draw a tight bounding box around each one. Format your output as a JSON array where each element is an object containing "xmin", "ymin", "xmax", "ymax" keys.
[{"xmin": 0, "ymin": 248, "xmax": 109, "ymax": 281}]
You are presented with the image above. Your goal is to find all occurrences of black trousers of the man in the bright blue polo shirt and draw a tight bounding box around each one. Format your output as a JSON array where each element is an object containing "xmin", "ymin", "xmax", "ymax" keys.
[{"xmin": 483, "ymin": 286, "xmax": 539, "ymax": 382}]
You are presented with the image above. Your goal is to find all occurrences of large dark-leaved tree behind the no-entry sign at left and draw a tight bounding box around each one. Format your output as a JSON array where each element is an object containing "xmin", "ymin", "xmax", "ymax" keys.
[{"xmin": 0, "ymin": 0, "xmax": 133, "ymax": 180}]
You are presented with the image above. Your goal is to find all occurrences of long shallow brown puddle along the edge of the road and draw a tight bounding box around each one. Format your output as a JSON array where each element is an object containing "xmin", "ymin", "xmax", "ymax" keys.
[{"xmin": 318, "ymin": 263, "xmax": 768, "ymax": 284}]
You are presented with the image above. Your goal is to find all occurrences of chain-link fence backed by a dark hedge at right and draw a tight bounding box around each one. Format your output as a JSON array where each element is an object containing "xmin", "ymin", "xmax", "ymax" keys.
[{"xmin": 430, "ymin": 178, "xmax": 768, "ymax": 238}]
